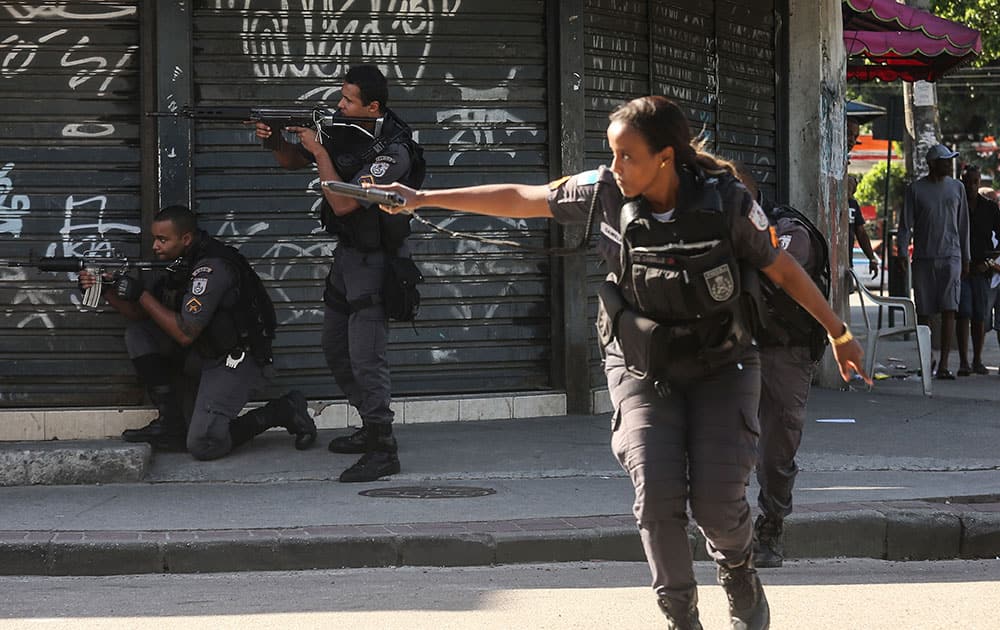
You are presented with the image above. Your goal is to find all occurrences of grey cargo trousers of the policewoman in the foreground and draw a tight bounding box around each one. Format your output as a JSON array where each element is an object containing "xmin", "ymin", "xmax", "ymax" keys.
[{"xmin": 605, "ymin": 342, "xmax": 760, "ymax": 603}]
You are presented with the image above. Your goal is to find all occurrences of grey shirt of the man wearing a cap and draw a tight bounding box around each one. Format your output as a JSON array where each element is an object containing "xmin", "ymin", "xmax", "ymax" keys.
[{"xmin": 898, "ymin": 177, "xmax": 969, "ymax": 262}]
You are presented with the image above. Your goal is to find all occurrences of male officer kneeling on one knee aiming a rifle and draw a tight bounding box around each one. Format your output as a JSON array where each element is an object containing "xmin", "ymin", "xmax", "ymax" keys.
[{"xmin": 80, "ymin": 206, "xmax": 316, "ymax": 460}]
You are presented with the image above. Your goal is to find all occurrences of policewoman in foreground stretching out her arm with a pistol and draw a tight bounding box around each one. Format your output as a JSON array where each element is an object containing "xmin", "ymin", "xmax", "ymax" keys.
[{"xmin": 379, "ymin": 96, "xmax": 867, "ymax": 628}]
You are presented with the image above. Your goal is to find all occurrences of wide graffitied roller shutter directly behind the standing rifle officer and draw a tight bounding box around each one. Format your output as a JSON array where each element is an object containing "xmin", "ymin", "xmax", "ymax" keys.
[{"xmin": 193, "ymin": 0, "xmax": 551, "ymax": 398}]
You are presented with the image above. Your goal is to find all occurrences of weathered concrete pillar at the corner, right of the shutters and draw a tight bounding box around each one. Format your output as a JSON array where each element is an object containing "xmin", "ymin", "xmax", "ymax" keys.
[{"xmin": 787, "ymin": 0, "xmax": 851, "ymax": 387}]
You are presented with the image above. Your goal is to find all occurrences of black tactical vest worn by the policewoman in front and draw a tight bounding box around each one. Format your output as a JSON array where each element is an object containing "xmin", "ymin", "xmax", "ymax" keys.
[{"xmin": 598, "ymin": 170, "xmax": 759, "ymax": 380}]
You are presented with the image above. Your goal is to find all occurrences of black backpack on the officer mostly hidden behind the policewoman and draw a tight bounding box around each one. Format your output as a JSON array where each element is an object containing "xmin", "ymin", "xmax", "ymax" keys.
[{"xmin": 758, "ymin": 205, "xmax": 830, "ymax": 361}]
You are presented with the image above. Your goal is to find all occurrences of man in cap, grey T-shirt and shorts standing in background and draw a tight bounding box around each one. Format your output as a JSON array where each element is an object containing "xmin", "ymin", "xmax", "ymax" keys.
[{"xmin": 898, "ymin": 144, "xmax": 969, "ymax": 380}]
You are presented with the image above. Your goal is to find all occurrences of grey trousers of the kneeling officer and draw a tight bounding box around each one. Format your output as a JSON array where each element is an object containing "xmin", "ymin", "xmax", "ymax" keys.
[{"xmin": 125, "ymin": 320, "xmax": 270, "ymax": 460}]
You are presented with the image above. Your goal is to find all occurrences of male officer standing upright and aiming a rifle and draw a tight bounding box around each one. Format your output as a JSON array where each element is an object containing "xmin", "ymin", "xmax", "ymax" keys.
[{"xmin": 256, "ymin": 65, "xmax": 423, "ymax": 482}]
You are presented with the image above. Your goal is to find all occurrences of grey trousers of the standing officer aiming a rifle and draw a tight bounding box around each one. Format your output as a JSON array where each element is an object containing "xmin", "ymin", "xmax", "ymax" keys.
[{"xmin": 322, "ymin": 245, "xmax": 393, "ymax": 424}]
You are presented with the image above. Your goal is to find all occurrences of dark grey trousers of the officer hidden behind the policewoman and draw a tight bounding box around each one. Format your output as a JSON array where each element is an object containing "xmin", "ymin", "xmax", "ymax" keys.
[{"xmin": 757, "ymin": 346, "xmax": 817, "ymax": 522}]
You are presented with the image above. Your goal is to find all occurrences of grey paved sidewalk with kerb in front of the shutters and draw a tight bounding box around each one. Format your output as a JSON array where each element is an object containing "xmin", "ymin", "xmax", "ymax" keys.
[{"xmin": 0, "ymin": 326, "xmax": 1000, "ymax": 575}]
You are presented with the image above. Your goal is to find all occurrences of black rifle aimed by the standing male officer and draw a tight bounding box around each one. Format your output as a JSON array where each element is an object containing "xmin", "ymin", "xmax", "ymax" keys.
[{"xmin": 147, "ymin": 105, "xmax": 384, "ymax": 149}]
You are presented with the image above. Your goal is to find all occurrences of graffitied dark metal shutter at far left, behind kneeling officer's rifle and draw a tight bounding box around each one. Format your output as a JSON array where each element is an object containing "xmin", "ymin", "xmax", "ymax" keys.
[{"xmin": 0, "ymin": 1, "xmax": 141, "ymax": 406}]
